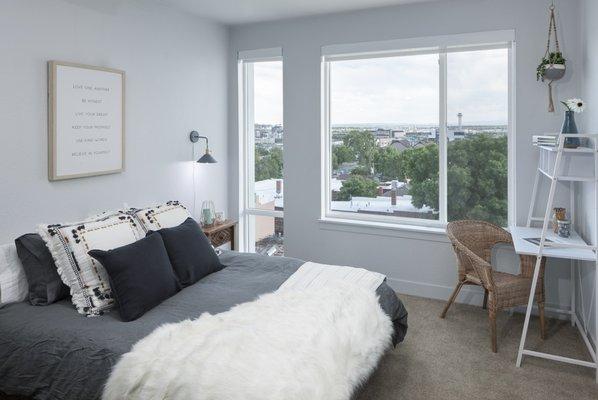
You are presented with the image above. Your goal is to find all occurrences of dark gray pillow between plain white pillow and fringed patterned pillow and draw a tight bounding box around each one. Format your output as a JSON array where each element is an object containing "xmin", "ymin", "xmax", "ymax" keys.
[{"xmin": 15, "ymin": 233, "xmax": 70, "ymax": 306}]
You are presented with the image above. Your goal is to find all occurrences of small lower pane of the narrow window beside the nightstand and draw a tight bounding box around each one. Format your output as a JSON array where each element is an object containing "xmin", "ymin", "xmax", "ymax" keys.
[{"xmin": 249, "ymin": 215, "xmax": 284, "ymax": 256}]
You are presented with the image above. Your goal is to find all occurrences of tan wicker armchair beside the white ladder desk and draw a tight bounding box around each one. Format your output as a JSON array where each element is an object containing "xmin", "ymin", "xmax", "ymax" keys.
[{"xmin": 440, "ymin": 221, "xmax": 546, "ymax": 353}]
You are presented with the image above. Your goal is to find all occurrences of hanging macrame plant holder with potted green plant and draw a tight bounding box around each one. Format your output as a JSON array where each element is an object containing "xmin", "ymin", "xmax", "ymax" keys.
[{"xmin": 537, "ymin": 4, "xmax": 566, "ymax": 112}]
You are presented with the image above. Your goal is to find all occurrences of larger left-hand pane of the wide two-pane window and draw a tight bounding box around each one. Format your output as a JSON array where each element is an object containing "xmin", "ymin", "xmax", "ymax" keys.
[{"xmin": 330, "ymin": 54, "xmax": 439, "ymax": 220}]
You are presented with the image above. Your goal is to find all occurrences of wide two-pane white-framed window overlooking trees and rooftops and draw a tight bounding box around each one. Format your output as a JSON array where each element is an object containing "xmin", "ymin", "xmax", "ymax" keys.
[{"xmin": 322, "ymin": 34, "xmax": 513, "ymax": 226}]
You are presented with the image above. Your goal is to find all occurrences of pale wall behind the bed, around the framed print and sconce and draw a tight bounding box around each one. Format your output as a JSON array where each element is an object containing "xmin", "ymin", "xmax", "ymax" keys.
[{"xmin": 0, "ymin": 0, "xmax": 228, "ymax": 243}]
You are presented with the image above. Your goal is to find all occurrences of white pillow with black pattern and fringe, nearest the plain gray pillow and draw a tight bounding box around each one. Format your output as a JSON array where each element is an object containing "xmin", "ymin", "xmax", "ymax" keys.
[{"xmin": 38, "ymin": 212, "xmax": 145, "ymax": 316}]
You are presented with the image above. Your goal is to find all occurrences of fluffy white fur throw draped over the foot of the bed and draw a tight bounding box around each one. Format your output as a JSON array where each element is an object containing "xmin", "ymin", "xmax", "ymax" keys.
[{"xmin": 103, "ymin": 285, "xmax": 392, "ymax": 400}]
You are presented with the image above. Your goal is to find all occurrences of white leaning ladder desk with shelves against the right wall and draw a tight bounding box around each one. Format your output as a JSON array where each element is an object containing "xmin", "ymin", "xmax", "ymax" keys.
[{"xmin": 509, "ymin": 134, "xmax": 598, "ymax": 383}]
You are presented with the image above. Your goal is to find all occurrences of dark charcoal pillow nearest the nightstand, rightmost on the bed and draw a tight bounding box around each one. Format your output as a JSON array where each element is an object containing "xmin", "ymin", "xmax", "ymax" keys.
[{"xmin": 147, "ymin": 218, "xmax": 224, "ymax": 287}]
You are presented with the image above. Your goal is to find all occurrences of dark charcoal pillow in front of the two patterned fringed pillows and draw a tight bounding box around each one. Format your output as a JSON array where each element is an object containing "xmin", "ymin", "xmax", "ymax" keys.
[{"xmin": 89, "ymin": 235, "xmax": 181, "ymax": 321}]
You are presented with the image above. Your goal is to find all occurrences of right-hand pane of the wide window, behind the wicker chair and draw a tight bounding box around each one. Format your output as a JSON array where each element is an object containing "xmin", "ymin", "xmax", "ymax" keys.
[{"xmin": 447, "ymin": 49, "xmax": 509, "ymax": 226}]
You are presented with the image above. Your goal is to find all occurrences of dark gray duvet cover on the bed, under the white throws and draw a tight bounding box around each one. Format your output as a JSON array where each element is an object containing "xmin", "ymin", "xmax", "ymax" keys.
[{"xmin": 0, "ymin": 252, "xmax": 407, "ymax": 400}]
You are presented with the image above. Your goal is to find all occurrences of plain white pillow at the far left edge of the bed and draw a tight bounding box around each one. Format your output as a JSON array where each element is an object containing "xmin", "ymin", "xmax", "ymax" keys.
[{"xmin": 0, "ymin": 243, "xmax": 29, "ymax": 304}]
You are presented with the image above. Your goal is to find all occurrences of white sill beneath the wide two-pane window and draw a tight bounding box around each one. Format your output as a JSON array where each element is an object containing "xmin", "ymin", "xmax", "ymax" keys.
[{"xmin": 318, "ymin": 217, "xmax": 449, "ymax": 243}]
